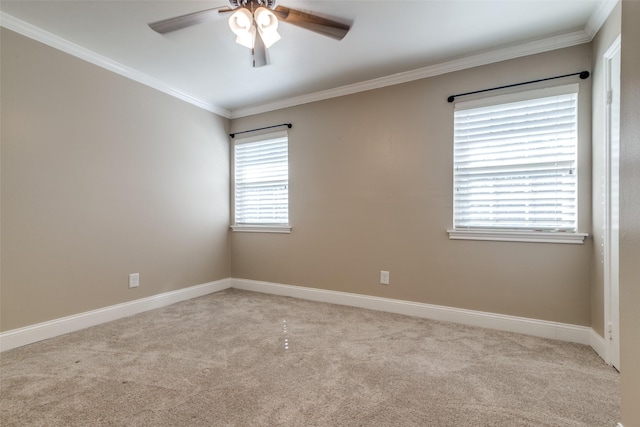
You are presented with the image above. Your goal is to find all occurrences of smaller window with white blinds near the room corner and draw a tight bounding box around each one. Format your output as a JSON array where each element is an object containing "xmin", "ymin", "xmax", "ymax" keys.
[{"xmin": 232, "ymin": 132, "xmax": 291, "ymax": 232}]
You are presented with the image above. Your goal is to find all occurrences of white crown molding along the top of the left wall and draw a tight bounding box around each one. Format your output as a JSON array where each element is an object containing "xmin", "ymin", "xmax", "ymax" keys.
[{"xmin": 0, "ymin": 11, "xmax": 231, "ymax": 118}]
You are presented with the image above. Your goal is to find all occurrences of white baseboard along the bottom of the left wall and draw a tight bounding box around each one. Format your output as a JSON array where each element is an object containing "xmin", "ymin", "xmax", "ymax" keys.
[{"xmin": 0, "ymin": 278, "xmax": 231, "ymax": 352}]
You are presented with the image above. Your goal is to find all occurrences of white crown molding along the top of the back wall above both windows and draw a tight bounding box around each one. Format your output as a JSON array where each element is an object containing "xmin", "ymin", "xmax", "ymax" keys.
[{"xmin": 230, "ymin": 31, "xmax": 591, "ymax": 119}]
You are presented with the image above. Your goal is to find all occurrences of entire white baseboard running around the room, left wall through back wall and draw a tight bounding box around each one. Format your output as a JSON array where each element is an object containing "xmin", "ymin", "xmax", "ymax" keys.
[{"xmin": 0, "ymin": 278, "xmax": 607, "ymax": 361}]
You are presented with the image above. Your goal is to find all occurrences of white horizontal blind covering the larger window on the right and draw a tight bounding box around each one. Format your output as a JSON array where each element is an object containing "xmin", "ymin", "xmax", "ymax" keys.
[{"xmin": 454, "ymin": 86, "xmax": 578, "ymax": 231}]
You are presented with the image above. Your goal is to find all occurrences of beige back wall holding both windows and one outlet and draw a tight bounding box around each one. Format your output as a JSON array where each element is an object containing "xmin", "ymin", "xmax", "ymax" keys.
[{"xmin": 231, "ymin": 45, "xmax": 593, "ymax": 325}]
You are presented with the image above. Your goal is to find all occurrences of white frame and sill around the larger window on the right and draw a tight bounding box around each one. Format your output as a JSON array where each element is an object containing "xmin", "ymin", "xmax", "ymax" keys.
[{"xmin": 447, "ymin": 83, "xmax": 588, "ymax": 244}]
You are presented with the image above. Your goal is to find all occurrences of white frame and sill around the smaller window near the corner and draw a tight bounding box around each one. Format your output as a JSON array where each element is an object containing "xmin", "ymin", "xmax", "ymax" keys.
[{"xmin": 230, "ymin": 131, "xmax": 292, "ymax": 233}]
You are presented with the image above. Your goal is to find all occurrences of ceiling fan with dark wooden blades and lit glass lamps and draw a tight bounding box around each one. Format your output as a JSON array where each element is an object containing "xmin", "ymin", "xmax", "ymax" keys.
[{"xmin": 149, "ymin": 0, "xmax": 351, "ymax": 67}]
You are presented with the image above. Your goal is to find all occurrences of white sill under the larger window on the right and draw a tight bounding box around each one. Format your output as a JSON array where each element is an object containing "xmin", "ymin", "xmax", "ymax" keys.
[{"xmin": 447, "ymin": 230, "xmax": 589, "ymax": 245}]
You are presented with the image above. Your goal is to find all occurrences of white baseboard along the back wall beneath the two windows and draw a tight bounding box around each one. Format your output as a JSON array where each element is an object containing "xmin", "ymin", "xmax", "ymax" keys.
[{"xmin": 231, "ymin": 278, "xmax": 600, "ymax": 351}]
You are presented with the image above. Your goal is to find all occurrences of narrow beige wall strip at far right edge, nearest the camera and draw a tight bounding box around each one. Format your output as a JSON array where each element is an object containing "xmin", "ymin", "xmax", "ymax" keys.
[{"xmin": 620, "ymin": 0, "xmax": 640, "ymax": 427}]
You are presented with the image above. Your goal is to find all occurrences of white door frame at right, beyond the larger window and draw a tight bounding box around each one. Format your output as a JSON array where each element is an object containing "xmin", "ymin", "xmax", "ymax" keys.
[{"xmin": 604, "ymin": 36, "xmax": 621, "ymax": 370}]
